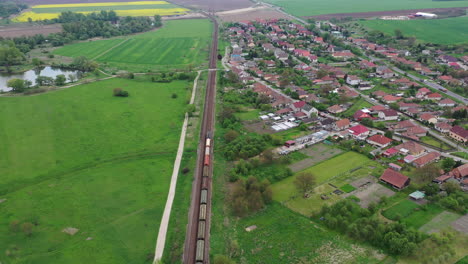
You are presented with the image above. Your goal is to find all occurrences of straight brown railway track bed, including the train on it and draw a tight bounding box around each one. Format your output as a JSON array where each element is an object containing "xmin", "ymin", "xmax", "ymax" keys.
[{"xmin": 183, "ymin": 13, "xmax": 218, "ymax": 264}]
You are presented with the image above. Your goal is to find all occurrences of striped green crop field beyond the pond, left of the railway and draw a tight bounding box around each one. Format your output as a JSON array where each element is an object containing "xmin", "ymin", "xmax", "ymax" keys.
[{"xmin": 54, "ymin": 19, "xmax": 212, "ymax": 72}]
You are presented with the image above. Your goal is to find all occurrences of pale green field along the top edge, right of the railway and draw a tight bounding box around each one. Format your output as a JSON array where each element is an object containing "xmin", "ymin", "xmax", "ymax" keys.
[{"xmin": 266, "ymin": 0, "xmax": 468, "ymax": 16}]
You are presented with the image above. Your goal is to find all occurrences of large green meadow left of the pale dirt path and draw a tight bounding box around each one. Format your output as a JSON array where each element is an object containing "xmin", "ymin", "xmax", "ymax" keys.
[{"xmin": 0, "ymin": 78, "xmax": 190, "ymax": 263}]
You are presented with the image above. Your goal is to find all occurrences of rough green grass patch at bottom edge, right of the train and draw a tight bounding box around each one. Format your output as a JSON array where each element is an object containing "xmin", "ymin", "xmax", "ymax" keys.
[{"xmin": 233, "ymin": 203, "xmax": 379, "ymax": 264}]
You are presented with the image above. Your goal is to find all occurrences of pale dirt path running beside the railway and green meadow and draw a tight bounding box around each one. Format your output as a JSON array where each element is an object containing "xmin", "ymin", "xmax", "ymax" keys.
[{"xmin": 154, "ymin": 71, "xmax": 202, "ymax": 262}]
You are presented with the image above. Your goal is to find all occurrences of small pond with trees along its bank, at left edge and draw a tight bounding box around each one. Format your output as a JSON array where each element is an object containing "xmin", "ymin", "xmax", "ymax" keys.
[{"xmin": 0, "ymin": 66, "xmax": 81, "ymax": 92}]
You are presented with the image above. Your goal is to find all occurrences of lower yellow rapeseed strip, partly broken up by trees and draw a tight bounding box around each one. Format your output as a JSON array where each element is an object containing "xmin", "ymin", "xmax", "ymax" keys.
[{"xmin": 13, "ymin": 8, "xmax": 188, "ymax": 22}]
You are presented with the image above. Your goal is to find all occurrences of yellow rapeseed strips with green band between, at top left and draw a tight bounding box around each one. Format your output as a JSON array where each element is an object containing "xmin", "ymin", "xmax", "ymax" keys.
[{"xmin": 13, "ymin": 1, "xmax": 189, "ymax": 22}]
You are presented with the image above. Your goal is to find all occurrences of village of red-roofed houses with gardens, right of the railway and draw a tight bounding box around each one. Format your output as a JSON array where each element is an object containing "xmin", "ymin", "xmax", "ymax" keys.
[{"xmin": 223, "ymin": 19, "xmax": 468, "ymax": 208}]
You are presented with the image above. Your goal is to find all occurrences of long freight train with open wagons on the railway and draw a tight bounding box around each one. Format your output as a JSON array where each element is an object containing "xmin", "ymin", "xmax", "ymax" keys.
[{"xmin": 195, "ymin": 133, "xmax": 213, "ymax": 264}]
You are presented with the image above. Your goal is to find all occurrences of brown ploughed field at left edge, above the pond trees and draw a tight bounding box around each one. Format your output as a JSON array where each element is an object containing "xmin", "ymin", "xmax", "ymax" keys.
[{"xmin": 0, "ymin": 24, "xmax": 62, "ymax": 38}]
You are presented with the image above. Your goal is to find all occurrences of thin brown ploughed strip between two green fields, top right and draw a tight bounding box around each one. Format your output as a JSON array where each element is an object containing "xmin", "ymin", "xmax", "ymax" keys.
[{"xmin": 305, "ymin": 7, "xmax": 467, "ymax": 20}]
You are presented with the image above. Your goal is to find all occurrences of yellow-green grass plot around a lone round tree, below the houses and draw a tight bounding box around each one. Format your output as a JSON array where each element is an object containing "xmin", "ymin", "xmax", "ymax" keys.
[{"xmin": 272, "ymin": 152, "xmax": 382, "ymax": 216}]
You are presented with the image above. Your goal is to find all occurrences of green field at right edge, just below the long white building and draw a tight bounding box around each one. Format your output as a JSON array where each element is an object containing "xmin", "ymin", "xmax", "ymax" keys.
[{"xmin": 359, "ymin": 16, "xmax": 468, "ymax": 44}]
